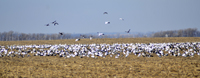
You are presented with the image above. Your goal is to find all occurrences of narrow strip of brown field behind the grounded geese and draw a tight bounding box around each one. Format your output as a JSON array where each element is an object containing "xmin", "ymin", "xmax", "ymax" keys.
[{"xmin": 0, "ymin": 37, "xmax": 200, "ymax": 45}]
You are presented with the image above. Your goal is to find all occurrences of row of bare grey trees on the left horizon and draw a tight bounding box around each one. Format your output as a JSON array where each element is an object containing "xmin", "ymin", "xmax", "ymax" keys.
[{"xmin": 0, "ymin": 31, "xmax": 71, "ymax": 41}]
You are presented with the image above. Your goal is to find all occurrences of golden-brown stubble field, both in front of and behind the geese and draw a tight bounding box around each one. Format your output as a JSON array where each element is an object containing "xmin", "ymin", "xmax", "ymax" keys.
[{"xmin": 0, "ymin": 37, "xmax": 200, "ymax": 78}]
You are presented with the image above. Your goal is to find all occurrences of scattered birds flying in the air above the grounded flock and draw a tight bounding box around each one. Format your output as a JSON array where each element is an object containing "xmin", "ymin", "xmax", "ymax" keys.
[{"xmin": 46, "ymin": 12, "xmax": 131, "ymax": 41}]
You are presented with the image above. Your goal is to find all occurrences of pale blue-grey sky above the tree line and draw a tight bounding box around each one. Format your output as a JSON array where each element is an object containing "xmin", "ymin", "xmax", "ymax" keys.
[{"xmin": 0, "ymin": 0, "xmax": 200, "ymax": 33}]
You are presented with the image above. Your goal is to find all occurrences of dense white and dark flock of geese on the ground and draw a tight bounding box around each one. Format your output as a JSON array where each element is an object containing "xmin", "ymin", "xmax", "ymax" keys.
[{"xmin": 0, "ymin": 42, "xmax": 200, "ymax": 59}]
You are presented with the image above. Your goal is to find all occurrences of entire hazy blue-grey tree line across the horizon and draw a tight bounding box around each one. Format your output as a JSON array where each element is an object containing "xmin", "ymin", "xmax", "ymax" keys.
[{"xmin": 0, "ymin": 28, "xmax": 200, "ymax": 41}]
